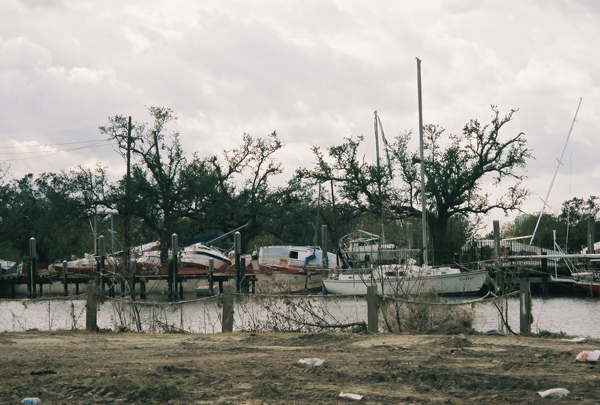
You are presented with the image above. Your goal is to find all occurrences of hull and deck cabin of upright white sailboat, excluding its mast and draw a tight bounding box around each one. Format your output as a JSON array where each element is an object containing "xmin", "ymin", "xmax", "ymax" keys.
[{"xmin": 323, "ymin": 259, "xmax": 488, "ymax": 295}]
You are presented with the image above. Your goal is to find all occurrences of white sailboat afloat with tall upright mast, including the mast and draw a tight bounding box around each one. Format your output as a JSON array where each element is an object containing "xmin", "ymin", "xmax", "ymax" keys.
[{"xmin": 323, "ymin": 58, "xmax": 488, "ymax": 295}]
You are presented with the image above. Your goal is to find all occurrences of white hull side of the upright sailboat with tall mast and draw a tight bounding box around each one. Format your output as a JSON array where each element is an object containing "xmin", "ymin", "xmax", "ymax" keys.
[{"xmin": 323, "ymin": 270, "xmax": 487, "ymax": 295}]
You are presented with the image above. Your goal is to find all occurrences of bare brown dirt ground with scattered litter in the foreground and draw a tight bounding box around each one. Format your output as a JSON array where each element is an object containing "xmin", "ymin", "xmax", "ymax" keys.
[{"xmin": 0, "ymin": 331, "xmax": 600, "ymax": 405}]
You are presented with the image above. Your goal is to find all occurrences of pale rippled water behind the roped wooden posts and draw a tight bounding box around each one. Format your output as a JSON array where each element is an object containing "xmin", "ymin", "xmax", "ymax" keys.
[{"xmin": 0, "ymin": 296, "xmax": 600, "ymax": 338}]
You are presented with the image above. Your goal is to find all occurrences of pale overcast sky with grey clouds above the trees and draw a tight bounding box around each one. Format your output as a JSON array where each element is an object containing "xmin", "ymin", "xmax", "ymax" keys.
[{"xmin": 0, "ymin": 0, "xmax": 600, "ymax": 229}]
